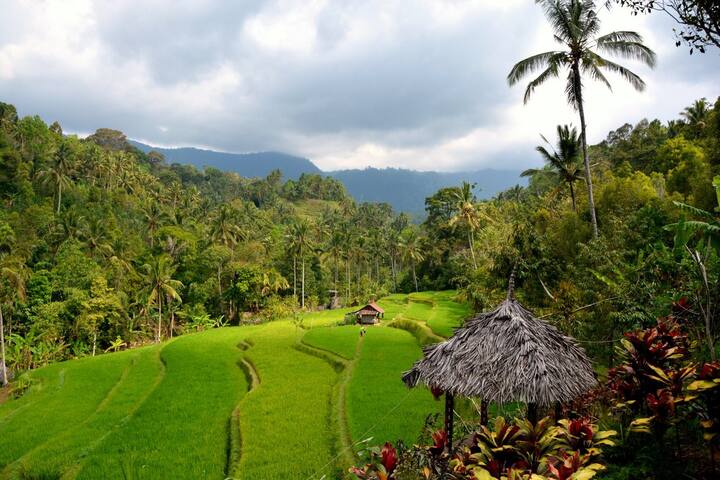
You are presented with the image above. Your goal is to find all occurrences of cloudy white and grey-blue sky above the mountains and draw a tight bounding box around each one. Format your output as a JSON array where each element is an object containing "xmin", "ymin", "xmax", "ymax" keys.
[{"xmin": 0, "ymin": 0, "xmax": 720, "ymax": 171}]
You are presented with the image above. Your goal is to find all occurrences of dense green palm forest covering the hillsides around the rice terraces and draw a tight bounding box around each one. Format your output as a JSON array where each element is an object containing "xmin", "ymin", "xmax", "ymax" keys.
[{"xmin": 0, "ymin": 94, "xmax": 720, "ymax": 372}]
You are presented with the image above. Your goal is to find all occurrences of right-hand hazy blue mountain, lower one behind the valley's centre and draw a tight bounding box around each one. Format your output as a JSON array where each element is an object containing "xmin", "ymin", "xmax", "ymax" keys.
[{"xmin": 325, "ymin": 168, "xmax": 527, "ymax": 214}]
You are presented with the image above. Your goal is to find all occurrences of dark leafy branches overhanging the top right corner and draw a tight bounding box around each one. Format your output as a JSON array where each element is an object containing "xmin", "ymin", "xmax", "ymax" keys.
[{"xmin": 606, "ymin": 0, "xmax": 720, "ymax": 55}]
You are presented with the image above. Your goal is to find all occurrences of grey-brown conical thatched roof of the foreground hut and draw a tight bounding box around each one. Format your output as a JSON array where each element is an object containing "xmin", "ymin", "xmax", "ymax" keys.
[{"xmin": 403, "ymin": 286, "xmax": 597, "ymax": 405}]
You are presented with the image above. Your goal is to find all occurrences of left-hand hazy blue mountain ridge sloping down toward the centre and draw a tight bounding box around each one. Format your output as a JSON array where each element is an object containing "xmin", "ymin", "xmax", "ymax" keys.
[{"xmin": 130, "ymin": 140, "xmax": 322, "ymax": 179}]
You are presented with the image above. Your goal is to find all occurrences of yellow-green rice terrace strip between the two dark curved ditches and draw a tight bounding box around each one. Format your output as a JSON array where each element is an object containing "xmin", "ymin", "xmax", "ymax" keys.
[{"xmin": 238, "ymin": 321, "xmax": 339, "ymax": 479}]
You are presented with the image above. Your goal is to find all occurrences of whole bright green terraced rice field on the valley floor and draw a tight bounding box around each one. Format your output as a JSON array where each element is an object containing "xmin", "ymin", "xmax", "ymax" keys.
[{"xmin": 0, "ymin": 292, "xmax": 468, "ymax": 479}]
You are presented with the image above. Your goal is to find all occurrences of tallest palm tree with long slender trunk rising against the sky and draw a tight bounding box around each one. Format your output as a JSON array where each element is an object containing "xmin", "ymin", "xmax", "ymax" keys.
[{"xmin": 507, "ymin": 0, "xmax": 655, "ymax": 238}]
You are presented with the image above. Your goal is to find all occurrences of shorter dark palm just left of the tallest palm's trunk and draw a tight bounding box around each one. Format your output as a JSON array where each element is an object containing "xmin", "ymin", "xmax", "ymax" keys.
[{"xmin": 520, "ymin": 125, "xmax": 583, "ymax": 212}]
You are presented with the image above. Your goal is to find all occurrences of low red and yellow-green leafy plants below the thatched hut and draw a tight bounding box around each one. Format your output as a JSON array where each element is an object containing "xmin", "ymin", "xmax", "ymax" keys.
[{"xmin": 350, "ymin": 417, "xmax": 615, "ymax": 480}]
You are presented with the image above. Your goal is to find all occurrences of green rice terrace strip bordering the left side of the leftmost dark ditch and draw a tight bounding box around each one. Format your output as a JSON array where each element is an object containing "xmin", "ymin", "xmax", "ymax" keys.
[{"xmin": 77, "ymin": 328, "xmax": 247, "ymax": 479}]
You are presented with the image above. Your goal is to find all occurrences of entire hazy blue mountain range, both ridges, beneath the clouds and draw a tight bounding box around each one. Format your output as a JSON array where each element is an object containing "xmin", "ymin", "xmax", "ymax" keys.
[{"xmin": 130, "ymin": 140, "xmax": 526, "ymax": 216}]
